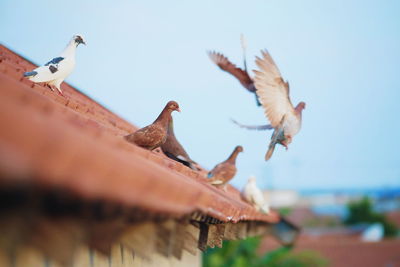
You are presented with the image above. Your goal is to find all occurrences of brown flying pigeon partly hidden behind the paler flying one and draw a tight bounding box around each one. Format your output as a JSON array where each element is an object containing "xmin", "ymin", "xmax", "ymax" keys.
[{"xmin": 208, "ymin": 35, "xmax": 261, "ymax": 106}]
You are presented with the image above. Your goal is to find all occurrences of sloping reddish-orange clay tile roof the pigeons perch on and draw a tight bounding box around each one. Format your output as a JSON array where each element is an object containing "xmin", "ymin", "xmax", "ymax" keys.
[{"xmin": 0, "ymin": 45, "xmax": 279, "ymax": 223}]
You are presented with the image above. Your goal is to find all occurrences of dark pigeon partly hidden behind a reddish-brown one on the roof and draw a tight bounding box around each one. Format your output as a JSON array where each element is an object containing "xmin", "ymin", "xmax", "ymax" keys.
[{"xmin": 161, "ymin": 118, "xmax": 198, "ymax": 170}]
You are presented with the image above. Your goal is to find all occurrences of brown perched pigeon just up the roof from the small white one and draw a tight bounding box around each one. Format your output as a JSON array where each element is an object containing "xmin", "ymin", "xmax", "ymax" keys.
[{"xmin": 208, "ymin": 146, "xmax": 243, "ymax": 191}]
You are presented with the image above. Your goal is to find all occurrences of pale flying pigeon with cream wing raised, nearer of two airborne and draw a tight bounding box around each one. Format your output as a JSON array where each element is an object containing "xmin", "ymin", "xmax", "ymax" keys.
[{"xmin": 233, "ymin": 50, "xmax": 306, "ymax": 160}]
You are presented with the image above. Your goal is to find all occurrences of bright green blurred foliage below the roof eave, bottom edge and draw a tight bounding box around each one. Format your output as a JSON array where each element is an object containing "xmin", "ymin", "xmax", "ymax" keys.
[{"xmin": 203, "ymin": 237, "xmax": 327, "ymax": 267}]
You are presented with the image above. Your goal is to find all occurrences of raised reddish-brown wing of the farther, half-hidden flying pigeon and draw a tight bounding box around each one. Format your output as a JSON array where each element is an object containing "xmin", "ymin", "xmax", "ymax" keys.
[{"xmin": 208, "ymin": 51, "xmax": 255, "ymax": 92}]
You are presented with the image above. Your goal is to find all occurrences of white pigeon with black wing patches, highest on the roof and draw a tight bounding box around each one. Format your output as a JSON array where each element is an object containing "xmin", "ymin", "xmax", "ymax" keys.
[{"xmin": 24, "ymin": 34, "xmax": 86, "ymax": 95}]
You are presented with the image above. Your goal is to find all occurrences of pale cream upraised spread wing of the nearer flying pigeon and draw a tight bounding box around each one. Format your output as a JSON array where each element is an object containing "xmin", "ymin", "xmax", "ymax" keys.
[{"xmin": 254, "ymin": 50, "xmax": 294, "ymax": 128}]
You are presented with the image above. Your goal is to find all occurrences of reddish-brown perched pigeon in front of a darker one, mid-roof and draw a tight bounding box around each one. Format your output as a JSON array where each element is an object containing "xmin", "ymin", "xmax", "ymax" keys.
[{"xmin": 124, "ymin": 101, "xmax": 180, "ymax": 150}]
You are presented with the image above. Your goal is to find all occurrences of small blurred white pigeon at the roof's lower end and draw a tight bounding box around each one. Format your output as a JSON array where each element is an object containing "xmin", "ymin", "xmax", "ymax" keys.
[{"xmin": 242, "ymin": 176, "xmax": 270, "ymax": 216}]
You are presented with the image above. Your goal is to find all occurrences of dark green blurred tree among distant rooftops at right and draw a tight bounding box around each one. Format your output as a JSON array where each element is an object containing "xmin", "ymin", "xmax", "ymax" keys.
[{"xmin": 344, "ymin": 197, "xmax": 397, "ymax": 237}]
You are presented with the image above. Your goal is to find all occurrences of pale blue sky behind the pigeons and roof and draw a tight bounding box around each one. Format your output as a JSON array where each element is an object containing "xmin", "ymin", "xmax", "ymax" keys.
[{"xmin": 0, "ymin": 0, "xmax": 400, "ymax": 193}]
